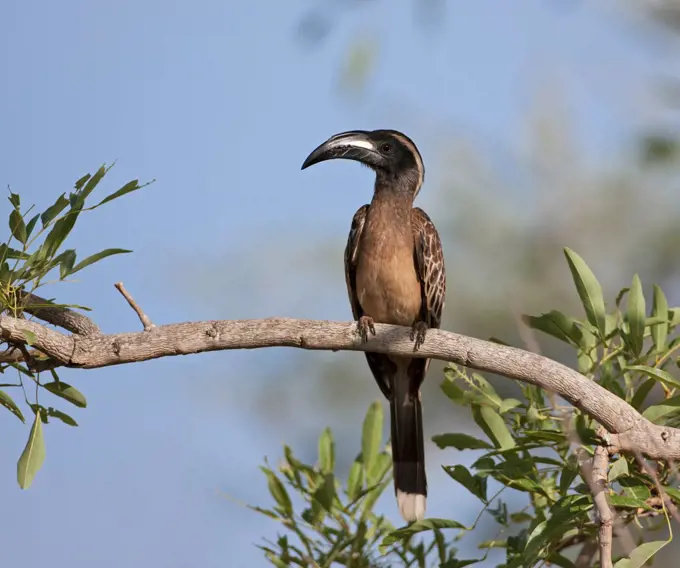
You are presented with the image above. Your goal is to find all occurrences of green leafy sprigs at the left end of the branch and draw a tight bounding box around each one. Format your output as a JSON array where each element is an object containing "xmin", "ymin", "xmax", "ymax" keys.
[{"xmin": 0, "ymin": 166, "xmax": 148, "ymax": 489}]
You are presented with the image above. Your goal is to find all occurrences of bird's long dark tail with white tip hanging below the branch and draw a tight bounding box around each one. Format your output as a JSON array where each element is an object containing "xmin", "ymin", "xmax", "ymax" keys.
[{"xmin": 390, "ymin": 369, "xmax": 427, "ymax": 522}]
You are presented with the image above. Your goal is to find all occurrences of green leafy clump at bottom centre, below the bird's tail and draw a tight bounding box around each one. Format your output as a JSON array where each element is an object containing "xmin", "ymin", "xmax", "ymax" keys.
[{"xmin": 251, "ymin": 402, "xmax": 470, "ymax": 568}]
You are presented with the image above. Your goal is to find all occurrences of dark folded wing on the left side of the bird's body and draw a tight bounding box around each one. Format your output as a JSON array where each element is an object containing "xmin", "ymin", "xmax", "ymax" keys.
[{"xmin": 345, "ymin": 205, "xmax": 394, "ymax": 399}]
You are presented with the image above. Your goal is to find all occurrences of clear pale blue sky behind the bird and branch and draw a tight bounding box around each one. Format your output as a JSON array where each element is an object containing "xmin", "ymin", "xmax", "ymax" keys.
[{"xmin": 0, "ymin": 0, "xmax": 660, "ymax": 568}]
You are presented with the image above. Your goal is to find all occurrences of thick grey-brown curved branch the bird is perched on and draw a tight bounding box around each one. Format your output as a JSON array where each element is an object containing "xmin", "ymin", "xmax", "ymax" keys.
[{"xmin": 0, "ymin": 314, "xmax": 680, "ymax": 460}]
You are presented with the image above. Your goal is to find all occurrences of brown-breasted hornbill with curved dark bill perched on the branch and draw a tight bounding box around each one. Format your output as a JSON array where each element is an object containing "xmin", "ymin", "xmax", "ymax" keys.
[{"xmin": 302, "ymin": 130, "xmax": 446, "ymax": 522}]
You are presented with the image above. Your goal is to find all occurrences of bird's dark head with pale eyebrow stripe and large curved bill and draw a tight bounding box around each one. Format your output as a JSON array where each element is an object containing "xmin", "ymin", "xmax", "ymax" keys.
[{"xmin": 302, "ymin": 130, "xmax": 425, "ymax": 197}]
